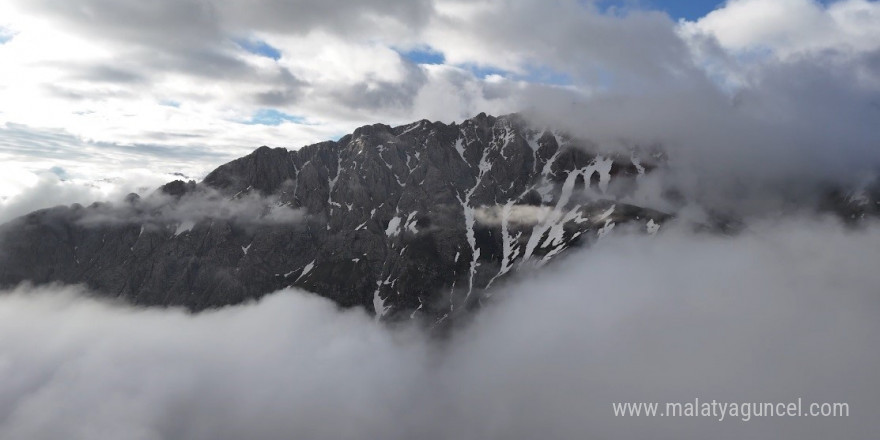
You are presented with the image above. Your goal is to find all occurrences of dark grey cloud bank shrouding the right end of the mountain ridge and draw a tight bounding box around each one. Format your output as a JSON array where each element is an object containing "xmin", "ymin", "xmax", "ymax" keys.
[{"xmin": 527, "ymin": 47, "xmax": 880, "ymax": 214}]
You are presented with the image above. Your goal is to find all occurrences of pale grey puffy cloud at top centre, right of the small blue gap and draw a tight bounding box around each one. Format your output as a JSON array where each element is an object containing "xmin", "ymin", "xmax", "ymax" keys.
[{"xmin": 425, "ymin": 0, "xmax": 693, "ymax": 87}]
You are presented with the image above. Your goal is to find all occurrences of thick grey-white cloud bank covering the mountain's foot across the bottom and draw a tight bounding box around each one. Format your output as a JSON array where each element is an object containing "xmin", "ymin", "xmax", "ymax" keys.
[{"xmin": 0, "ymin": 219, "xmax": 880, "ymax": 440}]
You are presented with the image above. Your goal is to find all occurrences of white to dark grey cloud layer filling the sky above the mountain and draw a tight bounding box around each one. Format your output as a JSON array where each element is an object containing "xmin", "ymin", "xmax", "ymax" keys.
[{"xmin": 0, "ymin": 0, "xmax": 880, "ymax": 220}]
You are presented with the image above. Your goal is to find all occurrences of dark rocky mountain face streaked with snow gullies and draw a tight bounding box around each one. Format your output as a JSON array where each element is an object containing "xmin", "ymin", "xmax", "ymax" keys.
[{"xmin": 0, "ymin": 114, "xmax": 668, "ymax": 321}]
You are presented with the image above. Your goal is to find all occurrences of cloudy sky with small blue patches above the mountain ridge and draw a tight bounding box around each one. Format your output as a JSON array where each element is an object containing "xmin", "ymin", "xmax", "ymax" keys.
[{"xmin": 0, "ymin": 0, "xmax": 880, "ymax": 219}]
